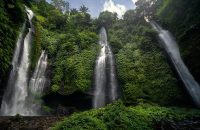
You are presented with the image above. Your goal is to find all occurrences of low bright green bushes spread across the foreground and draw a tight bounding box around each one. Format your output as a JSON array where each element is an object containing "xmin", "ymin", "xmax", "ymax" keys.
[{"xmin": 52, "ymin": 101, "xmax": 200, "ymax": 130}]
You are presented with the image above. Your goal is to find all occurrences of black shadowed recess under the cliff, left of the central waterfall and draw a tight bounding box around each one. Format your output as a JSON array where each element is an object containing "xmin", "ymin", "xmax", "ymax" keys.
[{"xmin": 43, "ymin": 92, "xmax": 92, "ymax": 115}]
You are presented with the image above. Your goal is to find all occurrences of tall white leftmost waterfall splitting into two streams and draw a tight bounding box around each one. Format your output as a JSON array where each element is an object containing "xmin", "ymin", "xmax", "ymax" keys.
[{"xmin": 1, "ymin": 8, "xmax": 34, "ymax": 115}]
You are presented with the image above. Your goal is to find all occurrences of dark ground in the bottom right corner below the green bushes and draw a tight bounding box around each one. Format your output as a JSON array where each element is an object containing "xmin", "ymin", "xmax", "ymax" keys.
[{"xmin": 154, "ymin": 118, "xmax": 200, "ymax": 130}]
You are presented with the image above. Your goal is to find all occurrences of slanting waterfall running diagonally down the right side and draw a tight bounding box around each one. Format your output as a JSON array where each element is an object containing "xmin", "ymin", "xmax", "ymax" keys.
[{"xmin": 150, "ymin": 22, "xmax": 200, "ymax": 107}]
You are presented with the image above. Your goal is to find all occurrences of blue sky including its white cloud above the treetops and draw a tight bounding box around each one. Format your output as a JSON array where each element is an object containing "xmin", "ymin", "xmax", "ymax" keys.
[{"xmin": 47, "ymin": 0, "xmax": 136, "ymax": 18}]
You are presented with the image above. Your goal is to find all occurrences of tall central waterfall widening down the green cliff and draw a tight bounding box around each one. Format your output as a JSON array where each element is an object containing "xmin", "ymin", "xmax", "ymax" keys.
[{"xmin": 93, "ymin": 28, "xmax": 119, "ymax": 108}]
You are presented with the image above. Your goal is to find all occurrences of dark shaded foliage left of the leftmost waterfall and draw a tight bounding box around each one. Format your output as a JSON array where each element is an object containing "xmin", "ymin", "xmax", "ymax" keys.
[{"xmin": 0, "ymin": 0, "xmax": 24, "ymax": 84}]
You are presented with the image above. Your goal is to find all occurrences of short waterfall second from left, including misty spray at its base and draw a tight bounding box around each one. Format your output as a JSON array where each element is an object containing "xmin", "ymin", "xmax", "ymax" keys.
[{"xmin": 26, "ymin": 51, "xmax": 47, "ymax": 116}]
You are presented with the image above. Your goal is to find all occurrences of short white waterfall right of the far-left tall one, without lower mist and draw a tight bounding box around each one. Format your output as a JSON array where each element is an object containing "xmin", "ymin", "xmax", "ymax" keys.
[{"xmin": 29, "ymin": 51, "xmax": 47, "ymax": 96}]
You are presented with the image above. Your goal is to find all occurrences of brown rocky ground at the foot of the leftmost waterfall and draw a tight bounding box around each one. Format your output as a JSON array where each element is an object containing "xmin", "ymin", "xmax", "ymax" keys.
[{"xmin": 0, "ymin": 116, "xmax": 64, "ymax": 130}]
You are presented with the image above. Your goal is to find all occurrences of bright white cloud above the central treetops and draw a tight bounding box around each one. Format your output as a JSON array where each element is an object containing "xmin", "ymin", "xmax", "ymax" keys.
[{"xmin": 103, "ymin": 0, "xmax": 126, "ymax": 18}]
